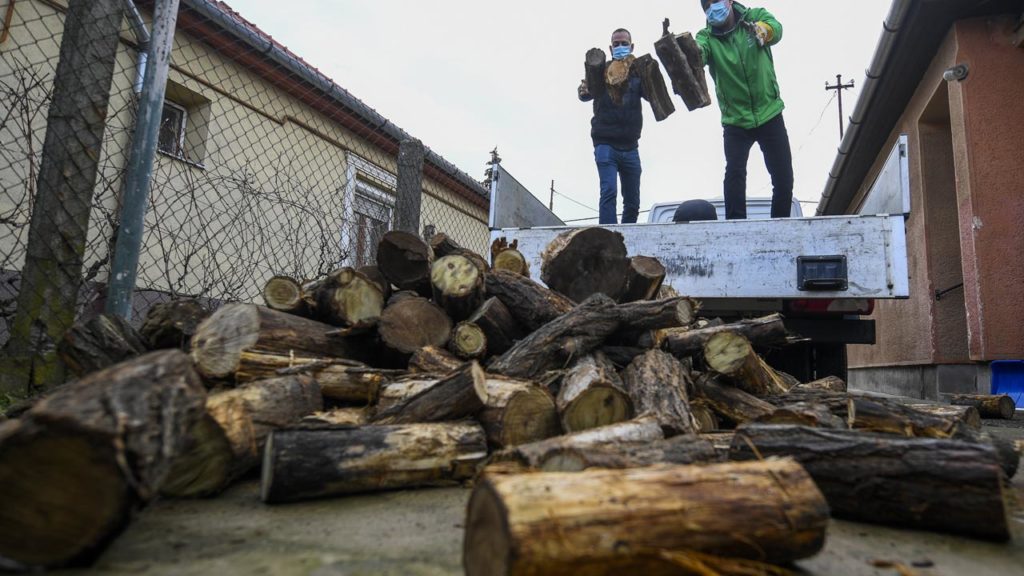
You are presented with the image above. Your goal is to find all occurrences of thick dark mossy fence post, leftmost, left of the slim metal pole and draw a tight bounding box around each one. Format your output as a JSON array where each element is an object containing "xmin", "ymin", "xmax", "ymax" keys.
[{"xmin": 0, "ymin": 0, "xmax": 124, "ymax": 397}]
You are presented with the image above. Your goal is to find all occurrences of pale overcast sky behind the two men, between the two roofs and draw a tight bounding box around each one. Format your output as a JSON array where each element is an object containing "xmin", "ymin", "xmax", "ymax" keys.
[{"xmin": 227, "ymin": 0, "xmax": 891, "ymax": 221}]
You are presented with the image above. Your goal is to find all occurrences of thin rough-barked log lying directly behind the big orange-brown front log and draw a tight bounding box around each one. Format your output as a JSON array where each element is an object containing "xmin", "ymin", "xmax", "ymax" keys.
[{"xmin": 541, "ymin": 436, "xmax": 723, "ymax": 472}]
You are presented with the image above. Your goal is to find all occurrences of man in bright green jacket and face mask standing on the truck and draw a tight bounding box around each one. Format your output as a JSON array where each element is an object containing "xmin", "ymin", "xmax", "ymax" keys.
[{"xmin": 696, "ymin": 0, "xmax": 793, "ymax": 219}]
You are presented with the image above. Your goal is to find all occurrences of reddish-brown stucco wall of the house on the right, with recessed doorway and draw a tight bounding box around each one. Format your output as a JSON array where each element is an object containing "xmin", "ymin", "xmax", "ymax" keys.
[{"xmin": 848, "ymin": 18, "xmax": 1024, "ymax": 397}]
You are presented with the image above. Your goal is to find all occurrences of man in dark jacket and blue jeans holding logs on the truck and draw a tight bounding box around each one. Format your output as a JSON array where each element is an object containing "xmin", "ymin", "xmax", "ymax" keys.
[{"xmin": 580, "ymin": 29, "xmax": 644, "ymax": 224}]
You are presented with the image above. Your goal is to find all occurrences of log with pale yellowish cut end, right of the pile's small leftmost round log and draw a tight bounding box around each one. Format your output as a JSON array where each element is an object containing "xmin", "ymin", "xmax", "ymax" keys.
[{"xmin": 308, "ymin": 268, "xmax": 384, "ymax": 328}]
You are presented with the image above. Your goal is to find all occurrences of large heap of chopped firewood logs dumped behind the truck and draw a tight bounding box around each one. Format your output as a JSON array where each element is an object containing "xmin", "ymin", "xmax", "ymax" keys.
[{"xmin": 0, "ymin": 228, "xmax": 1019, "ymax": 575}]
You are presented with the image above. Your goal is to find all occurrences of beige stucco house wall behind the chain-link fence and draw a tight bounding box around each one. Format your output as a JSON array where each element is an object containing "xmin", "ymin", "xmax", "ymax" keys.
[{"xmin": 0, "ymin": 0, "xmax": 488, "ymax": 300}]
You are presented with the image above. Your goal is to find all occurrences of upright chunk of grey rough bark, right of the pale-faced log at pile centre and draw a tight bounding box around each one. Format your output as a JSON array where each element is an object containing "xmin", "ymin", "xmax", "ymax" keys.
[{"xmin": 623, "ymin": 351, "xmax": 697, "ymax": 437}]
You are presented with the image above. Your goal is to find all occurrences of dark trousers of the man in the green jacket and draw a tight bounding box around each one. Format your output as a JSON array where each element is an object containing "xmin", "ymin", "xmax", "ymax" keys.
[{"xmin": 724, "ymin": 114, "xmax": 793, "ymax": 220}]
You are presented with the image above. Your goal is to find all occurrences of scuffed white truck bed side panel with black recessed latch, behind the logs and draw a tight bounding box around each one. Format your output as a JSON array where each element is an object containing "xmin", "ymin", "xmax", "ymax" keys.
[{"xmin": 492, "ymin": 215, "xmax": 909, "ymax": 299}]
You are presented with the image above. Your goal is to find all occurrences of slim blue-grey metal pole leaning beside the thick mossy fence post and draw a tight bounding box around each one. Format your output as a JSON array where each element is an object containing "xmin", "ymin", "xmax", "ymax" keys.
[{"xmin": 106, "ymin": 0, "xmax": 178, "ymax": 320}]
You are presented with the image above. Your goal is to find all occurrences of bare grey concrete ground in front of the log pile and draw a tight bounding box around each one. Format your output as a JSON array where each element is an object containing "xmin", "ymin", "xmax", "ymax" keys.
[{"xmin": 54, "ymin": 421, "xmax": 1024, "ymax": 576}]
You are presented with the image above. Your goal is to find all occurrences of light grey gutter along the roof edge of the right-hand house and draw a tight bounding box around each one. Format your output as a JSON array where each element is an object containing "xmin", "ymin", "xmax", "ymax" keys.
[{"xmin": 817, "ymin": 0, "xmax": 915, "ymax": 216}]
